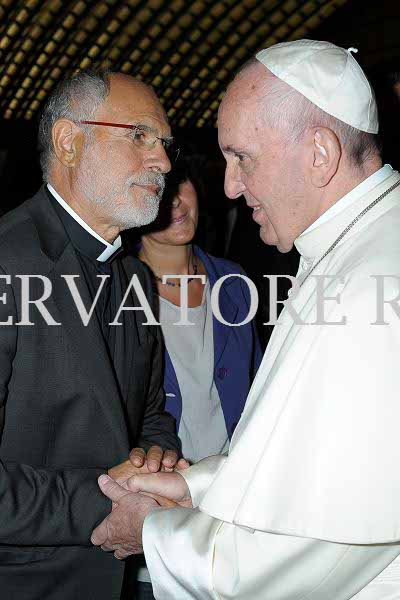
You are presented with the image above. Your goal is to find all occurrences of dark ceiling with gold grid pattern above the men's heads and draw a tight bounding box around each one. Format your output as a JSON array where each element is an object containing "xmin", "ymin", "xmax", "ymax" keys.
[{"xmin": 0, "ymin": 0, "xmax": 347, "ymax": 127}]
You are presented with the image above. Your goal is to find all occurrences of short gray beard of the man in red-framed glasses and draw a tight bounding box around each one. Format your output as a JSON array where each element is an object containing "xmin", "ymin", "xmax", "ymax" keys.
[{"xmin": 79, "ymin": 158, "xmax": 165, "ymax": 230}]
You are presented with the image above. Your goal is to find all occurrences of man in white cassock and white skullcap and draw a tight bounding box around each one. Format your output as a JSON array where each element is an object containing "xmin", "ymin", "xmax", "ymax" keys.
[{"xmin": 94, "ymin": 40, "xmax": 400, "ymax": 600}]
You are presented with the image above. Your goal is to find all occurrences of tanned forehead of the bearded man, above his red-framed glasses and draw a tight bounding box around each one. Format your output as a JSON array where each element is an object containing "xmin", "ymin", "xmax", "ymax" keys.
[{"xmin": 96, "ymin": 73, "xmax": 170, "ymax": 135}]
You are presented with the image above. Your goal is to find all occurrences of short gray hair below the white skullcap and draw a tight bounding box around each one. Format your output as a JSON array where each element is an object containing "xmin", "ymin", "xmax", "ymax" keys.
[{"xmin": 237, "ymin": 58, "xmax": 381, "ymax": 168}]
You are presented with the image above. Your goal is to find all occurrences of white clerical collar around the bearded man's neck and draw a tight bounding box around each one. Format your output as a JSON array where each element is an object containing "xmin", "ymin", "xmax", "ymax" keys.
[{"xmin": 47, "ymin": 183, "xmax": 122, "ymax": 263}]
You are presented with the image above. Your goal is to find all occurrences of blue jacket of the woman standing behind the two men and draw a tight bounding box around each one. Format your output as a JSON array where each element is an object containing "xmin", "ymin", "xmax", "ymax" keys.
[{"xmin": 164, "ymin": 246, "xmax": 262, "ymax": 438}]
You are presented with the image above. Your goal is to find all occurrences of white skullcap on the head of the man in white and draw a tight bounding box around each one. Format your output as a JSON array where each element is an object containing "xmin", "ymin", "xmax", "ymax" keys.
[{"xmin": 256, "ymin": 40, "xmax": 379, "ymax": 133}]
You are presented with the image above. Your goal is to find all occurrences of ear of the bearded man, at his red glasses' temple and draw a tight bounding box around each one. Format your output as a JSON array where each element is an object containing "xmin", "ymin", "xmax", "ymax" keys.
[{"xmin": 52, "ymin": 119, "xmax": 84, "ymax": 168}]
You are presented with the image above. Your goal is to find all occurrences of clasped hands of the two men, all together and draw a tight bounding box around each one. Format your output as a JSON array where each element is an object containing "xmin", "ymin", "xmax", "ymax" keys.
[{"xmin": 91, "ymin": 446, "xmax": 192, "ymax": 559}]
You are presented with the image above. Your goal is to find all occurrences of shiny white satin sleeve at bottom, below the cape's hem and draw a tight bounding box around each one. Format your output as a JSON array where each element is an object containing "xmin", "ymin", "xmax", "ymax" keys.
[{"xmin": 143, "ymin": 508, "xmax": 400, "ymax": 600}]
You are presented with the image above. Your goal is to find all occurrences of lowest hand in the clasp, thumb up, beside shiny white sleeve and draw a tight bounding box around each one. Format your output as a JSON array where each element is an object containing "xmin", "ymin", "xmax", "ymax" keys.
[{"xmin": 91, "ymin": 475, "xmax": 157, "ymax": 559}]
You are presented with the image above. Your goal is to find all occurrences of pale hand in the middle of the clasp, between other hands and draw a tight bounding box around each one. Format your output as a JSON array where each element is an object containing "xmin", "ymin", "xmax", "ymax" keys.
[{"xmin": 125, "ymin": 471, "xmax": 193, "ymax": 508}]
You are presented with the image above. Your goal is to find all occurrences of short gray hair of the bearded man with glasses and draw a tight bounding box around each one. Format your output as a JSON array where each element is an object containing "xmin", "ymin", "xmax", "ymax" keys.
[{"xmin": 38, "ymin": 69, "xmax": 110, "ymax": 182}]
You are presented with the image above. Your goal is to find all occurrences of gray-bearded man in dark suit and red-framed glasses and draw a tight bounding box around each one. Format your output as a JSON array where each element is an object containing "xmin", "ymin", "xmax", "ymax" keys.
[{"xmin": 0, "ymin": 72, "xmax": 183, "ymax": 600}]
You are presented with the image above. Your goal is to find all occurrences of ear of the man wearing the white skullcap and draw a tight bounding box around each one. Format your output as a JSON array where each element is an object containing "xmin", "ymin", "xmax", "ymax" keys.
[{"xmin": 311, "ymin": 127, "xmax": 342, "ymax": 188}]
